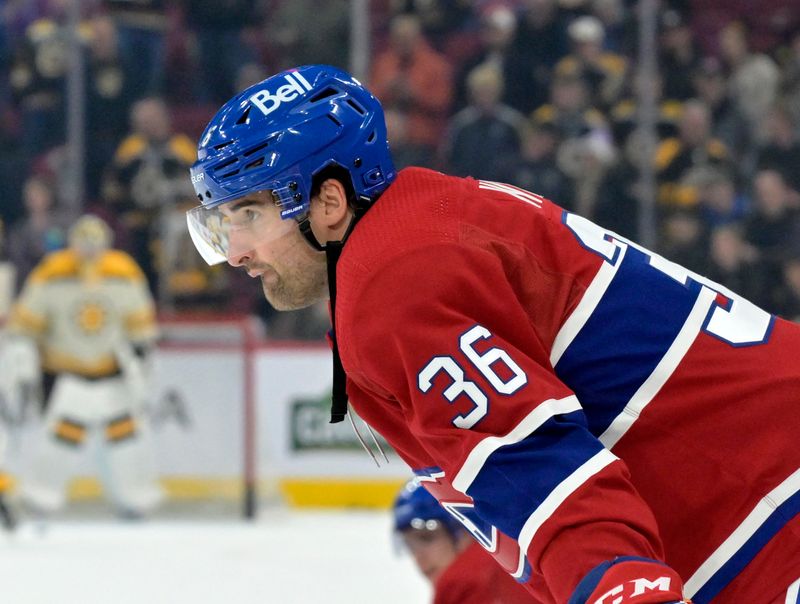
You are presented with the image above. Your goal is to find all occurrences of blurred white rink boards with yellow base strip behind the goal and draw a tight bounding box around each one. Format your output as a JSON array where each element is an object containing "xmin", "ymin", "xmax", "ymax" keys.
[{"xmin": 7, "ymin": 345, "xmax": 410, "ymax": 507}]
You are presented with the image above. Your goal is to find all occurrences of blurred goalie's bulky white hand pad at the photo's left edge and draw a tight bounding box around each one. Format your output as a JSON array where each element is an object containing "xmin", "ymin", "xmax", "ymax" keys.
[{"xmin": 0, "ymin": 335, "xmax": 42, "ymax": 423}]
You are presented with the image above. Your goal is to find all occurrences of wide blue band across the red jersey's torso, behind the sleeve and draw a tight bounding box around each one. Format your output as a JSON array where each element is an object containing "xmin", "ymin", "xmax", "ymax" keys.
[{"xmin": 555, "ymin": 247, "xmax": 701, "ymax": 436}]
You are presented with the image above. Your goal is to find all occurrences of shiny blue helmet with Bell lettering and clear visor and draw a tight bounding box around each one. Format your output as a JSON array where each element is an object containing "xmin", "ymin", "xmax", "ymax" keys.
[{"xmin": 187, "ymin": 65, "xmax": 396, "ymax": 264}]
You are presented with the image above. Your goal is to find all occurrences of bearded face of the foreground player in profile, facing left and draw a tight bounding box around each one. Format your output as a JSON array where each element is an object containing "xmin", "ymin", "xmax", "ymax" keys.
[{"xmin": 221, "ymin": 191, "xmax": 328, "ymax": 310}]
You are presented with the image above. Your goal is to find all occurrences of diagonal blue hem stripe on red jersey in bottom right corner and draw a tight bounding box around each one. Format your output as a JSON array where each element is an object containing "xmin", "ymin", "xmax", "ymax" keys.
[{"xmin": 692, "ymin": 491, "xmax": 800, "ymax": 604}]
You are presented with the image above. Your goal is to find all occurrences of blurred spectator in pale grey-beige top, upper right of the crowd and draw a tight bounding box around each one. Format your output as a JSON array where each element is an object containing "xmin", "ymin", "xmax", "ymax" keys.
[{"xmin": 719, "ymin": 21, "xmax": 780, "ymax": 140}]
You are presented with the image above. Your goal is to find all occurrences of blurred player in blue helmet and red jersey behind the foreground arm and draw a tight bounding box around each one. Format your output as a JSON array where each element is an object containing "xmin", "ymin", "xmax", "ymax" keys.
[{"xmin": 393, "ymin": 479, "xmax": 535, "ymax": 604}]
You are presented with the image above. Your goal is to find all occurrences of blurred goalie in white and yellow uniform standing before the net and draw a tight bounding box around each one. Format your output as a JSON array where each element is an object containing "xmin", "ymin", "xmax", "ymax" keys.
[{"xmin": 8, "ymin": 215, "xmax": 162, "ymax": 517}]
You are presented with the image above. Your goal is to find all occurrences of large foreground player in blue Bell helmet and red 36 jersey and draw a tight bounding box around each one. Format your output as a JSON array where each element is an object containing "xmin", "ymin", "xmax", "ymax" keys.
[{"xmin": 188, "ymin": 66, "xmax": 800, "ymax": 604}]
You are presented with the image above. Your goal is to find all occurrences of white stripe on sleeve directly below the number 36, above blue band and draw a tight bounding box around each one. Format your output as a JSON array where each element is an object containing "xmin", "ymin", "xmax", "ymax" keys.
[{"xmin": 452, "ymin": 395, "xmax": 581, "ymax": 495}]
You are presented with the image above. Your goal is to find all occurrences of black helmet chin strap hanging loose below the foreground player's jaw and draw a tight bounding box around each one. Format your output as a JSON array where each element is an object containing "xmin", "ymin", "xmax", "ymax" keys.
[{"xmin": 298, "ymin": 199, "xmax": 368, "ymax": 424}]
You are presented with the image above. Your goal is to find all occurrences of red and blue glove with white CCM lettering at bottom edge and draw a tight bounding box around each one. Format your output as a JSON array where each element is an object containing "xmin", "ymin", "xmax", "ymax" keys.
[{"xmin": 569, "ymin": 556, "xmax": 691, "ymax": 604}]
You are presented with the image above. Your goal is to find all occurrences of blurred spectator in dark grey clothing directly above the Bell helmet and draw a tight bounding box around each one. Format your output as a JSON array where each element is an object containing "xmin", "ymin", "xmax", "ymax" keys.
[{"xmin": 266, "ymin": 0, "xmax": 350, "ymax": 71}]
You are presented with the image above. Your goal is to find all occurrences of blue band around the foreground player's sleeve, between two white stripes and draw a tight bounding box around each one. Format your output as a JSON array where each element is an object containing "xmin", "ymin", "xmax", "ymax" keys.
[{"xmin": 467, "ymin": 411, "xmax": 603, "ymax": 539}]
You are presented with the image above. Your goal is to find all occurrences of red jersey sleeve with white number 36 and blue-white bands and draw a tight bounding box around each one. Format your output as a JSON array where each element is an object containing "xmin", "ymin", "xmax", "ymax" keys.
[{"xmin": 341, "ymin": 242, "xmax": 663, "ymax": 602}]
